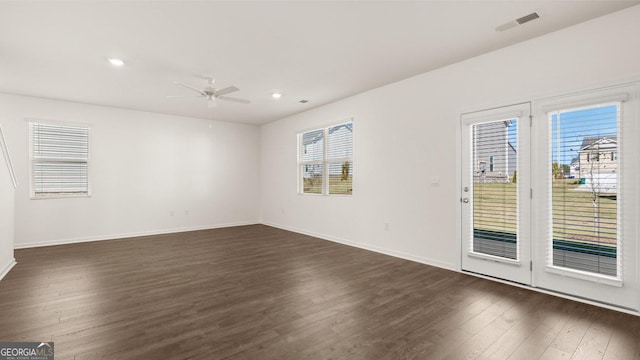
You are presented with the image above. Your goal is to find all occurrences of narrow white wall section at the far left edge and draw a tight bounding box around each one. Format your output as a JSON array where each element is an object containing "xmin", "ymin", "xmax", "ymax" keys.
[{"xmin": 0, "ymin": 125, "xmax": 15, "ymax": 279}]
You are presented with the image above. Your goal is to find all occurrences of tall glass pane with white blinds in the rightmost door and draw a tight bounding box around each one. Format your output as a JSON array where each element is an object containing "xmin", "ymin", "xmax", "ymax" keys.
[{"xmin": 548, "ymin": 102, "xmax": 624, "ymax": 277}]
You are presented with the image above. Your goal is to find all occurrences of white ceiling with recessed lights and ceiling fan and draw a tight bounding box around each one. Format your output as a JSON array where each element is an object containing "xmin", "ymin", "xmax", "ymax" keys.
[{"xmin": 0, "ymin": 1, "xmax": 640, "ymax": 124}]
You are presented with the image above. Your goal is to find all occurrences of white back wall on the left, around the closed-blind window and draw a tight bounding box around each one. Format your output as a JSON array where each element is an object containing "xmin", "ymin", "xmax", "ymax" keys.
[{"xmin": 0, "ymin": 94, "xmax": 260, "ymax": 247}]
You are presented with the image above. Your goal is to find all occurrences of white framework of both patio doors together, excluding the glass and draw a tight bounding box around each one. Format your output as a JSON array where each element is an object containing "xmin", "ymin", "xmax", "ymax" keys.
[{"xmin": 458, "ymin": 81, "xmax": 640, "ymax": 313}]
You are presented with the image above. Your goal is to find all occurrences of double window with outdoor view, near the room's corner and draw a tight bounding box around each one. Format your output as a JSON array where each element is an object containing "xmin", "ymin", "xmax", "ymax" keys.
[{"xmin": 298, "ymin": 121, "xmax": 353, "ymax": 195}]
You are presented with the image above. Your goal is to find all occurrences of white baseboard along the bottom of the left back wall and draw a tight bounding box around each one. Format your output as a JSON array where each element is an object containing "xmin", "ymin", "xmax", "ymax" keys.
[{"xmin": 14, "ymin": 221, "xmax": 259, "ymax": 249}]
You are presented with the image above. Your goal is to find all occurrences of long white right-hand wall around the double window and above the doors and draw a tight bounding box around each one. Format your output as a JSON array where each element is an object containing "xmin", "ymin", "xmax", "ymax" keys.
[{"xmin": 260, "ymin": 6, "xmax": 640, "ymax": 269}]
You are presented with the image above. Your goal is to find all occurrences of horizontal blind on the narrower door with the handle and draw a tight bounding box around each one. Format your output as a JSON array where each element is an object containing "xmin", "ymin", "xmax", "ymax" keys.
[{"xmin": 471, "ymin": 119, "xmax": 518, "ymax": 260}]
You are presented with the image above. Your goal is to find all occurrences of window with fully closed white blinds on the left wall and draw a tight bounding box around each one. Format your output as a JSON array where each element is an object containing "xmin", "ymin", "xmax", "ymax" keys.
[{"xmin": 29, "ymin": 121, "xmax": 89, "ymax": 198}]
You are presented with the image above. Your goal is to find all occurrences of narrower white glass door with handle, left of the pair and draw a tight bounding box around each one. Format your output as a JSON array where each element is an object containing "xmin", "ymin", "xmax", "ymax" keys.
[{"xmin": 460, "ymin": 103, "xmax": 531, "ymax": 284}]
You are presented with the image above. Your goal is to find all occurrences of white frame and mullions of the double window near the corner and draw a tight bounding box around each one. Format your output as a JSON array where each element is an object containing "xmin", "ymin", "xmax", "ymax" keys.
[{"xmin": 296, "ymin": 118, "xmax": 354, "ymax": 197}]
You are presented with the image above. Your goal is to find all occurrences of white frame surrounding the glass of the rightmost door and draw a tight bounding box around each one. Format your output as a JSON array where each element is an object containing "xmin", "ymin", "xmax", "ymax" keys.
[{"xmin": 532, "ymin": 84, "xmax": 640, "ymax": 310}]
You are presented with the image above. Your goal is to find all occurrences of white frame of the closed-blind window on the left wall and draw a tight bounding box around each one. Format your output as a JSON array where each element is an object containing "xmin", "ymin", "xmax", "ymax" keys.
[{"xmin": 25, "ymin": 118, "xmax": 92, "ymax": 200}]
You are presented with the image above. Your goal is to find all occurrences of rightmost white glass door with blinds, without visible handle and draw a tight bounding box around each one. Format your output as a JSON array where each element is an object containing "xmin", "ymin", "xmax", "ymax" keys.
[{"xmin": 533, "ymin": 86, "xmax": 639, "ymax": 309}]
